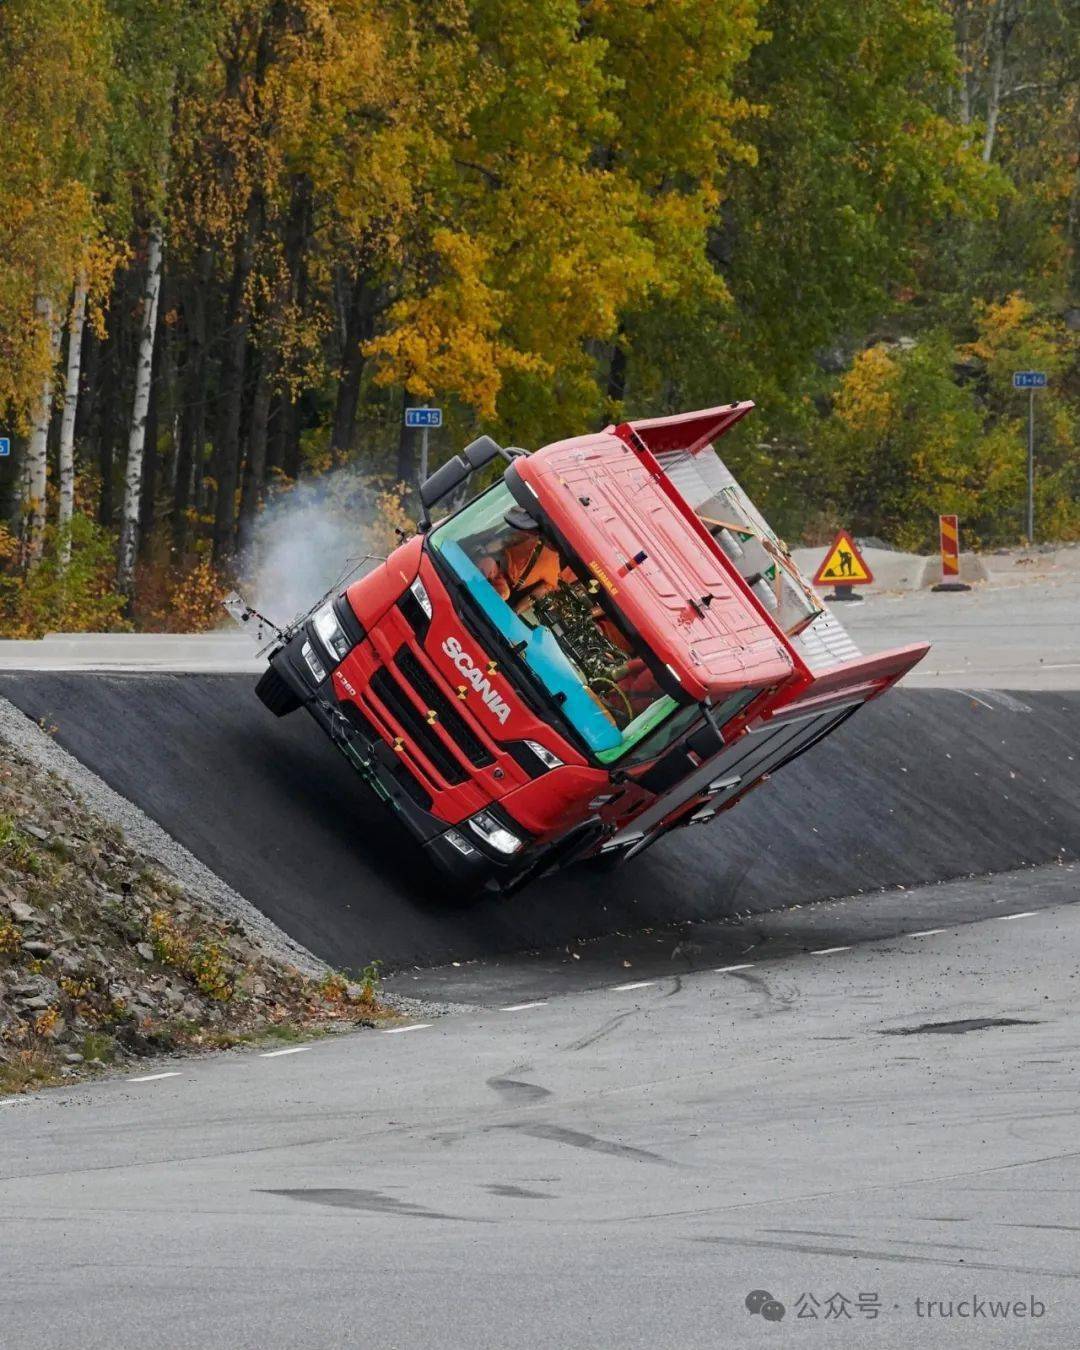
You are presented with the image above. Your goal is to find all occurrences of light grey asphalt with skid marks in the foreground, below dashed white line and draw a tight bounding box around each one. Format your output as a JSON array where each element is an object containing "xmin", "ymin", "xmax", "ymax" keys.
[{"xmin": 0, "ymin": 885, "xmax": 1080, "ymax": 1350}]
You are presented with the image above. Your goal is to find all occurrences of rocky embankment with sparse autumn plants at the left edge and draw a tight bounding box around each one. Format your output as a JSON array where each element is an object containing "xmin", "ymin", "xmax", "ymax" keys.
[{"xmin": 0, "ymin": 741, "xmax": 393, "ymax": 1092}]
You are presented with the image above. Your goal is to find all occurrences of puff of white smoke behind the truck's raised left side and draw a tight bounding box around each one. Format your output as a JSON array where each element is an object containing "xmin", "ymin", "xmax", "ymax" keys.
[{"xmin": 242, "ymin": 466, "xmax": 394, "ymax": 625}]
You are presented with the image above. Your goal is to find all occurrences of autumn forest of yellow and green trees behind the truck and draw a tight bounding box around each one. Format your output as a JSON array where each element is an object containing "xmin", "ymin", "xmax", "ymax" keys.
[{"xmin": 0, "ymin": 0, "xmax": 1080, "ymax": 636}]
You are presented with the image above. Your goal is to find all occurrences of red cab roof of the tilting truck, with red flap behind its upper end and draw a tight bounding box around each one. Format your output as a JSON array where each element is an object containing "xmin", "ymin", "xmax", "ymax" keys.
[{"xmin": 514, "ymin": 402, "xmax": 801, "ymax": 699}]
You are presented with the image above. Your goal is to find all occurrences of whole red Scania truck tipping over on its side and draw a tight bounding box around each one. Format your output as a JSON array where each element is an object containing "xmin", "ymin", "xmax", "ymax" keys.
[{"xmin": 257, "ymin": 402, "xmax": 929, "ymax": 891}]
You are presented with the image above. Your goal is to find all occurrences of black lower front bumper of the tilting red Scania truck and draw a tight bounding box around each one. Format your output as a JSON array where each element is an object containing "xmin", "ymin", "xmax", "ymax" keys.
[{"xmin": 270, "ymin": 624, "xmax": 523, "ymax": 890}]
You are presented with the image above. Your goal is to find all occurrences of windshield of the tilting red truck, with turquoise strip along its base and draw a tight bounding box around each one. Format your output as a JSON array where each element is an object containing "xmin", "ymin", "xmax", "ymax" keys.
[{"xmin": 428, "ymin": 483, "xmax": 701, "ymax": 763}]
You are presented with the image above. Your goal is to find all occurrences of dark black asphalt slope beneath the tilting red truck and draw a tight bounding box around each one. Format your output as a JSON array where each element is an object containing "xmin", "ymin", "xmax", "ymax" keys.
[{"xmin": 0, "ymin": 672, "xmax": 1080, "ymax": 968}]
